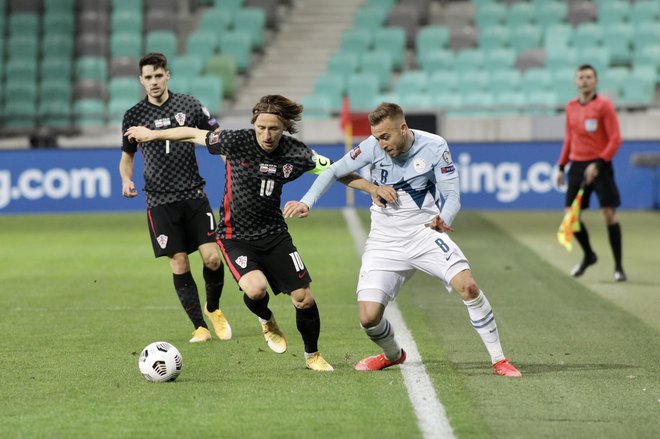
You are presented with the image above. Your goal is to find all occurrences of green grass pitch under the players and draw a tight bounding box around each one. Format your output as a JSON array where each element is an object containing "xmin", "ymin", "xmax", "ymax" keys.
[{"xmin": 0, "ymin": 210, "xmax": 660, "ymax": 439}]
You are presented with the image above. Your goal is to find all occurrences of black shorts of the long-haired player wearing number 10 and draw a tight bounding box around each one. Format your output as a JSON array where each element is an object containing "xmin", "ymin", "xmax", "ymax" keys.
[{"xmin": 218, "ymin": 232, "xmax": 312, "ymax": 294}]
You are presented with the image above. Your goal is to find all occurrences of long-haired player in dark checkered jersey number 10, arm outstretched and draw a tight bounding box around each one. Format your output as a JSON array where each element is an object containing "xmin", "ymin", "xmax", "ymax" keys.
[{"xmin": 126, "ymin": 95, "xmax": 377, "ymax": 371}]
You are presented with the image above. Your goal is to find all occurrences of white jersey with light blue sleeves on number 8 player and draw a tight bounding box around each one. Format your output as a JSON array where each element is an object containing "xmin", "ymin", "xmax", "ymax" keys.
[{"xmin": 301, "ymin": 130, "xmax": 460, "ymax": 238}]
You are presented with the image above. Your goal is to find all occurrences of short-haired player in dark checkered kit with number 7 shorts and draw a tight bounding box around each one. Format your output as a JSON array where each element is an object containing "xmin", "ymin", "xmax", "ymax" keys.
[{"xmin": 119, "ymin": 53, "xmax": 232, "ymax": 343}]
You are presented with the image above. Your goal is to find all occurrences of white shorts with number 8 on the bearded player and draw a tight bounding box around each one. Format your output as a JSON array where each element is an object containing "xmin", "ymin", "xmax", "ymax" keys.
[{"xmin": 357, "ymin": 227, "xmax": 470, "ymax": 305}]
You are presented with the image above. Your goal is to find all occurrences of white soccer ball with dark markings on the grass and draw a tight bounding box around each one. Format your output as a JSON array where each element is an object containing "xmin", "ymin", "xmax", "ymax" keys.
[{"xmin": 138, "ymin": 341, "xmax": 183, "ymax": 383}]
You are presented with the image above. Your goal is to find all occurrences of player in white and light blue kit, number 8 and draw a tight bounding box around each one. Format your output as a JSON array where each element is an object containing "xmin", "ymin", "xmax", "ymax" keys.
[{"xmin": 284, "ymin": 103, "xmax": 520, "ymax": 377}]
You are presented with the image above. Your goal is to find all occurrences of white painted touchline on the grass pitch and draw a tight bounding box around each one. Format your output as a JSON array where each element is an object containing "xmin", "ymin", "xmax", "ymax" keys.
[{"xmin": 342, "ymin": 209, "xmax": 456, "ymax": 439}]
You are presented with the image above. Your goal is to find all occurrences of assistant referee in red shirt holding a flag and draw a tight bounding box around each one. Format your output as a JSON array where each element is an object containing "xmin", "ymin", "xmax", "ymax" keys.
[{"xmin": 557, "ymin": 64, "xmax": 626, "ymax": 282}]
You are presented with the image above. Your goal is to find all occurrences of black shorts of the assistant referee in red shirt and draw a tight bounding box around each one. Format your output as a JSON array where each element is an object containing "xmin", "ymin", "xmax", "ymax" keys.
[{"xmin": 566, "ymin": 161, "xmax": 621, "ymax": 209}]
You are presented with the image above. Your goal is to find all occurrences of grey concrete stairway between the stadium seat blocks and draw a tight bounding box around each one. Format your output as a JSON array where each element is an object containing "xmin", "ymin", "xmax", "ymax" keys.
[{"xmin": 232, "ymin": 0, "xmax": 363, "ymax": 113}]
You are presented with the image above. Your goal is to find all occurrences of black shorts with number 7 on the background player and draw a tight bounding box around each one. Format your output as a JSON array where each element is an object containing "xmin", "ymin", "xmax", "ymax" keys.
[{"xmin": 147, "ymin": 198, "xmax": 216, "ymax": 258}]
